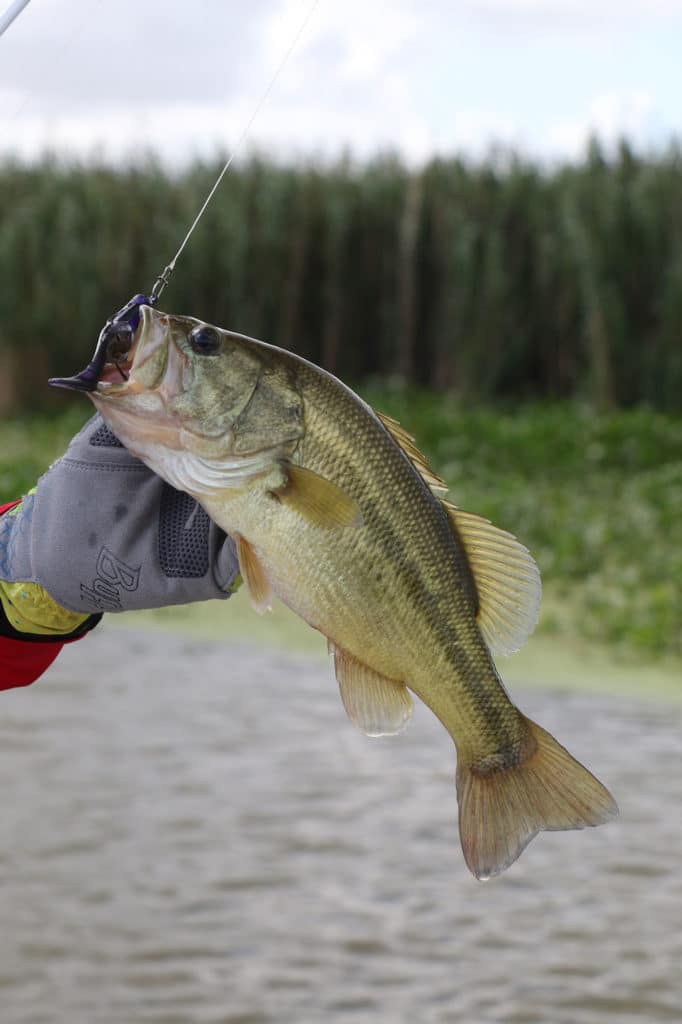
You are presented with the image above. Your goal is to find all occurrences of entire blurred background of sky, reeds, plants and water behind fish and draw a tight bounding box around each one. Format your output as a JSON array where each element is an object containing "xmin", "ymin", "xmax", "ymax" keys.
[{"xmin": 0, "ymin": 0, "xmax": 682, "ymax": 1024}]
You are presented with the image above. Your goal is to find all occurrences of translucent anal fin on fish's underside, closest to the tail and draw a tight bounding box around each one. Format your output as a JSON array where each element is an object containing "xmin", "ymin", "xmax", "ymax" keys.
[{"xmin": 329, "ymin": 641, "xmax": 412, "ymax": 736}]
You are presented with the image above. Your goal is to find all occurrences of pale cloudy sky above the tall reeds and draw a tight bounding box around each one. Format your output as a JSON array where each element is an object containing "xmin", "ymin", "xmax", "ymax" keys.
[{"xmin": 0, "ymin": 0, "xmax": 682, "ymax": 162}]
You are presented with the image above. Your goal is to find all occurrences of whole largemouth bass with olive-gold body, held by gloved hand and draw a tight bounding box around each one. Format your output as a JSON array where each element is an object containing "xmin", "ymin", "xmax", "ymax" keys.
[{"xmin": 90, "ymin": 305, "xmax": 617, "ymax": 880}]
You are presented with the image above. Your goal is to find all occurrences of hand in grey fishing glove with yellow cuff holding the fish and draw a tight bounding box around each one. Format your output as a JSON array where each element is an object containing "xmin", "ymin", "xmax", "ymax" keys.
[{"xmin": 0, "ymin": 416, "xmax": 240, "ymax": 635}]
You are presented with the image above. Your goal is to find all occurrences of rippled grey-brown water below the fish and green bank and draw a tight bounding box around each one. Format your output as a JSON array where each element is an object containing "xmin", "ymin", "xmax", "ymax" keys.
[{"xmin": 0, "ymin": 629, "xmax": 682, "ymax": 1024}]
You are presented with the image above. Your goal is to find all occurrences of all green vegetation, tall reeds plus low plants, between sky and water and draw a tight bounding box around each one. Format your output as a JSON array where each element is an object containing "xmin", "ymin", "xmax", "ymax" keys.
[{"xmin": 0, "ymin": 144, "xmax": 682, "ymax": 658}]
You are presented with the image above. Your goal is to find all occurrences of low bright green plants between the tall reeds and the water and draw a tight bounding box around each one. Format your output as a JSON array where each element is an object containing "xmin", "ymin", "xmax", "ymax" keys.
[{"xmin": 0, "ymin": 395, "xmax": 682, "ymax": 657}]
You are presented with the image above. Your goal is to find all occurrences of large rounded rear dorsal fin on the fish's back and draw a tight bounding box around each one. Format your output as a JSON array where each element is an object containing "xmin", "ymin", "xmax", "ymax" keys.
[{"xmin": 442, "ymin": 501, "xmax": 542, "ymax": 654}]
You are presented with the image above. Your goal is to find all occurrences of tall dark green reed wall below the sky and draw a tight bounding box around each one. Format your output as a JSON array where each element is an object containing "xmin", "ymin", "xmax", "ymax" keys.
[{"xmin": 0, "ymin": 144, "xmax": 682, "ymax": 412}]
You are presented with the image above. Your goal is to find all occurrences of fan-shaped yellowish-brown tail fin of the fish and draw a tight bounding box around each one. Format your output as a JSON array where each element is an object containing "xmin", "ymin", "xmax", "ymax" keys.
[{"xmin": 457, "ymin": 718, "xmax": 619, "ymax": 879}]
